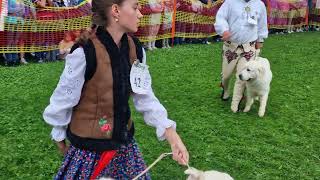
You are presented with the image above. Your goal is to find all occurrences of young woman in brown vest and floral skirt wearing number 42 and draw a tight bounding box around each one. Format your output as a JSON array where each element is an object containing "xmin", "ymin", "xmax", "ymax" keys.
[{"xmin": 43, "ymin": 0, "xmax": 189, "ymax": 179}]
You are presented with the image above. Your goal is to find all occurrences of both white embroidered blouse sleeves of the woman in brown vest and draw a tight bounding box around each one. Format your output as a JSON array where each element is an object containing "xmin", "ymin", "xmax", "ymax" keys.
[{"xmin": 43, "ymin": 48, "xmax": 176, "ymax": 141}]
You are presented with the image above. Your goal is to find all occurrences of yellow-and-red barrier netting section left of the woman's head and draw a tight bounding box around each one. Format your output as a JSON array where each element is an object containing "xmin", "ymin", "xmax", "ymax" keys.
[{"xmin": 0, "ymin": 0, "xmax": 91, "ymax": 53}]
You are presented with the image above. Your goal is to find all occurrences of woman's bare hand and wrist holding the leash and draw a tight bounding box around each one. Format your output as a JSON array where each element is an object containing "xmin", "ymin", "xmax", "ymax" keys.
[{"xmin": 165, "ymin": 128, "xmax": 189, "ymax": 165}]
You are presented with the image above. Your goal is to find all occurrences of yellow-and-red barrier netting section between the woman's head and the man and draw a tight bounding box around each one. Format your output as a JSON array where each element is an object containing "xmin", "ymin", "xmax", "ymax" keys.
[{"xmin": 135, "ymin": 0, "xmax": 222, "ymax": 41}]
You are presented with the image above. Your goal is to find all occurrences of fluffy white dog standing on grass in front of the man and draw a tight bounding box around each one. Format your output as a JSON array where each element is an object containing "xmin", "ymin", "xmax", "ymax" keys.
[{"xmin": 238, "ymin": 57, "xmax": 272, "ymax": 117}]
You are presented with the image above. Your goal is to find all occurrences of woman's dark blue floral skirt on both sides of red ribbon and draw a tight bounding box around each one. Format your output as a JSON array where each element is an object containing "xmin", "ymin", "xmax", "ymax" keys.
[{"xmin": 54, "ymin": 139, "xmax": 151, "ymax": 180}]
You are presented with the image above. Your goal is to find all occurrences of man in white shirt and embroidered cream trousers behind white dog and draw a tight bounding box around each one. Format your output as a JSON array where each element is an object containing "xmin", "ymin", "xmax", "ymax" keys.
[{"xmin": 214, "ymin": 0, "xmax": 268, "ymax": 112}]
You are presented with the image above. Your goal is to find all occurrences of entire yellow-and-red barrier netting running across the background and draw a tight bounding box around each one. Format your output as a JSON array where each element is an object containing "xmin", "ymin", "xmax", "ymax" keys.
[{"xmin": 0, "ymin": 0, "xmax": 320, "ymax": 53}]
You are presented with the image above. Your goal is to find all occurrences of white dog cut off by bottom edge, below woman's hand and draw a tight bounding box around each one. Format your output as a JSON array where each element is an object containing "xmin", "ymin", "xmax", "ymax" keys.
[{"xmin": 184, "ymin": 167, "xmax": 233, "ymax": 180}]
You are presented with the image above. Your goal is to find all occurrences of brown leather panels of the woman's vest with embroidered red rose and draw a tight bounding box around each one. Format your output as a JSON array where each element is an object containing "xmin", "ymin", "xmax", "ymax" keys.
[{"xmin": 69, "ymin": 35, "xmax": 137, "ymax": 141}]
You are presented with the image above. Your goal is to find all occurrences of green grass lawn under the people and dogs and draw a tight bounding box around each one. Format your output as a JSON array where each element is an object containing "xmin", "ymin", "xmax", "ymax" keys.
[{"xmin": 0, "ymin": 32, "xmax": 320, "ymax": 180}]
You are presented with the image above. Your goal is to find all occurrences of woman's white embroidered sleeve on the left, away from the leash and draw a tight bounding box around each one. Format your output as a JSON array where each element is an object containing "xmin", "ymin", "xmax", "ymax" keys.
[{"xmin": 43, "ymin": 48, "xmax": 86, "ymax": 142}]
